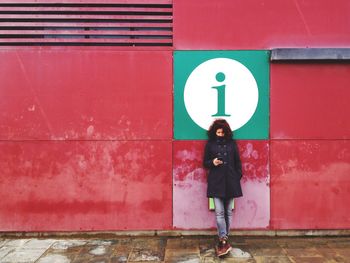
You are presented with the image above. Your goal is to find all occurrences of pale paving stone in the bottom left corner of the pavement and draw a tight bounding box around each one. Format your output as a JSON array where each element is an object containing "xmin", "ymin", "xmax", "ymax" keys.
[{"xmin": 1, "ymin": 249, "xmax": 45, "ymax": 263}]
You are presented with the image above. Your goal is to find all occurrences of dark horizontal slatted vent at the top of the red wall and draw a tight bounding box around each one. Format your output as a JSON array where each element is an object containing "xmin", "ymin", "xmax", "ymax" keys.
[{"xmin": 0, "ymin": 0, "xmax": 173, "ymax": 47}]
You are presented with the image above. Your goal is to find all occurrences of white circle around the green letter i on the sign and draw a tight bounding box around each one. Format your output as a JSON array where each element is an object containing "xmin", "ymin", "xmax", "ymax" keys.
[{"xmin": 184, "ymin": 58, "xmax": 259, "ymax": 131}]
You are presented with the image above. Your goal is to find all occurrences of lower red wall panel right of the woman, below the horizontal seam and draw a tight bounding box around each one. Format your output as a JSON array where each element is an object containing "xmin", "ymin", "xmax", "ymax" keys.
[{"xmin": 271, "ymin": 140, "xmax": 350, "ymax": 229}]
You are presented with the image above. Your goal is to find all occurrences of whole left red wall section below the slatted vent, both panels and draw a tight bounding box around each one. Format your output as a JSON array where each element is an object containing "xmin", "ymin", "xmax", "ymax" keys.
[{"xmin": 0, "ymin": 48, "xmax": 172, "ymax": 231}]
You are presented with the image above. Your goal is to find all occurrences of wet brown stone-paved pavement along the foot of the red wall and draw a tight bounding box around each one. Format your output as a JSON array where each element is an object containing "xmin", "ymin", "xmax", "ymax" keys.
[{"xmin": 0, "ymin": 236, "xmax": 350, "ymax": 263}]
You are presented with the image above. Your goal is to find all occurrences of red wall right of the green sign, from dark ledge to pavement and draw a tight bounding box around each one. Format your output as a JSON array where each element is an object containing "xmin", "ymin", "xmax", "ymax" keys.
[{"xmin": 270, "ymin": 63, "xmax": 350, "ymax": 229}]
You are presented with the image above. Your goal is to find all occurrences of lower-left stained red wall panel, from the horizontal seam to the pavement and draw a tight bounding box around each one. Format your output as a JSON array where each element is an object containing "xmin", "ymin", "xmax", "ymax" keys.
[{"xmin": 0, "ymin": 141, "xmax": 172, "ymax": 231}]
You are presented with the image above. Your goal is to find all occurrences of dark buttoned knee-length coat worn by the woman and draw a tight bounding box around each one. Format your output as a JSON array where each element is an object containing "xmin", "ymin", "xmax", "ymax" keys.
[{"xmin": 203, "ymin": 138, "xmax": 243, "ymax": 198}]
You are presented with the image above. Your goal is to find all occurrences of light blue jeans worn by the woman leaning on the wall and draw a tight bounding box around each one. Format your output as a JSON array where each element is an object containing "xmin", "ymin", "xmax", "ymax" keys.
[{"xmin": 213, "ymin": 197, "xmax": 233, "ymax": 238}]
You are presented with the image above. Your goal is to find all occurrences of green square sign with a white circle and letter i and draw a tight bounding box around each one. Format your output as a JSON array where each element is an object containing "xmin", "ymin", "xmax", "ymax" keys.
[{"xmin": 174, "ymin": 50, "xmax": 269, "ymax": 140}]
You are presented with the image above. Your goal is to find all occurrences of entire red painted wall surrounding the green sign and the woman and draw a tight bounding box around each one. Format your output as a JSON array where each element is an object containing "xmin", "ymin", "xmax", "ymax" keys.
[{"xmin": 0, "ymin": 0, "xmax": 350, "ymax": 231}]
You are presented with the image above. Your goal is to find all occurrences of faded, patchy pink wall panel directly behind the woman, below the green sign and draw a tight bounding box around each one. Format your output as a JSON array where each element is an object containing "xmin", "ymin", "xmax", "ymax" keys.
[{"xmin": 173, "ymin": 141, "xmax": 270, "ymax": 229}]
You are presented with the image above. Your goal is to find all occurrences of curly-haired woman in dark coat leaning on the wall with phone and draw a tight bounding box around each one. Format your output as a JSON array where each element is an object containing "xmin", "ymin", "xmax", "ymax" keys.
[{"xmin": 204, "ymin": 119, "xmax": 243, "ymax": 256}]
